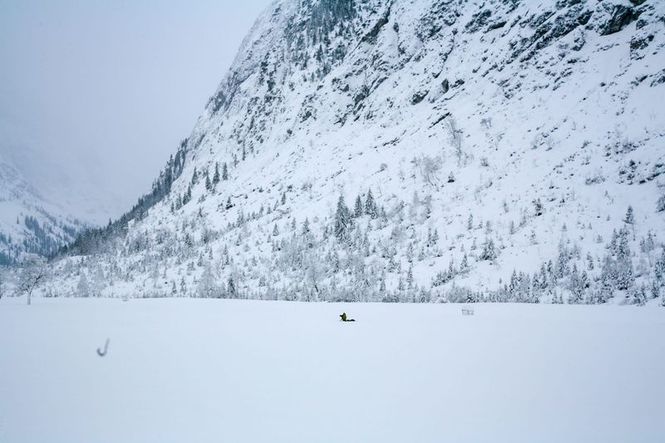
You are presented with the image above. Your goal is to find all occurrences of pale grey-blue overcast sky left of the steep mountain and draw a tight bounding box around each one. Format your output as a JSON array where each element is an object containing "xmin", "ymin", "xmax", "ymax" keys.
[{"xmin": 0, "ymin": 0, "xmax": 271, "ymax": 220}]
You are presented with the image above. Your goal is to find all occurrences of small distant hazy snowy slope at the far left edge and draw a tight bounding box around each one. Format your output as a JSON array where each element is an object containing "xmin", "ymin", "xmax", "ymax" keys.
[{"xmin": 0, "ymin": 154, "xmax": 85, "ymax": 265}]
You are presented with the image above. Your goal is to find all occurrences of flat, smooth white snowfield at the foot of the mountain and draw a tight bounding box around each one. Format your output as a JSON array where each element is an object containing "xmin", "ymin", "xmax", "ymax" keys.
[{"xmin": 0, "ymin": 299, "xmax": 665, "ymax": 443}]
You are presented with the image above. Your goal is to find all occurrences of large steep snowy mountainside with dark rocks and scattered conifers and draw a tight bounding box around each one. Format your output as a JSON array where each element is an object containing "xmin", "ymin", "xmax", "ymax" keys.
[{"xmin": 40, "ymin": 0, "xmax": 665, "ymax": 303}]
